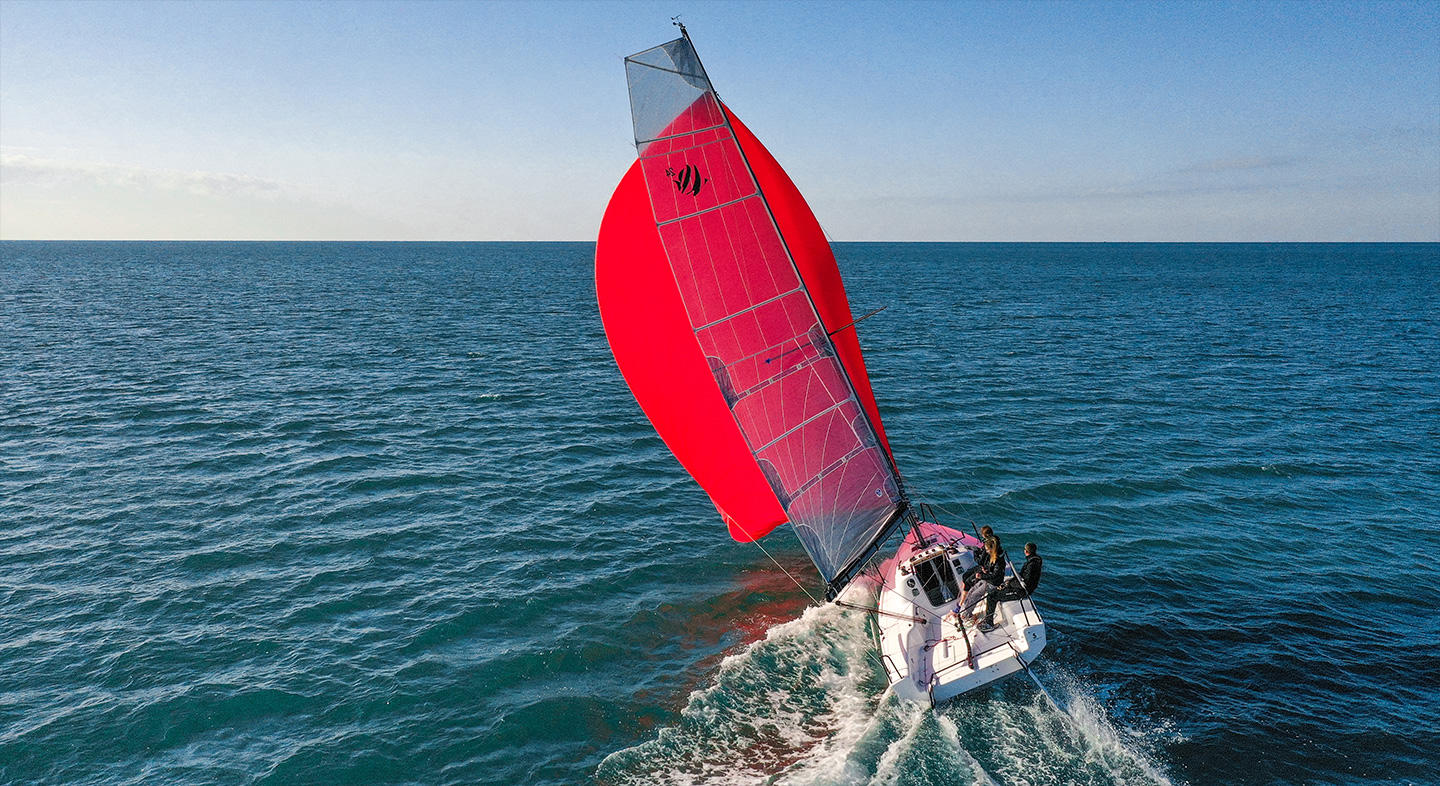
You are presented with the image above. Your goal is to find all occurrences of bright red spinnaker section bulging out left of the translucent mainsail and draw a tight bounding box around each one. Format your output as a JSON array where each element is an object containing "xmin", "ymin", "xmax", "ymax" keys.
[{"xmin": 595, "ymin": 161, "xmax": 785, "ymax": 541}]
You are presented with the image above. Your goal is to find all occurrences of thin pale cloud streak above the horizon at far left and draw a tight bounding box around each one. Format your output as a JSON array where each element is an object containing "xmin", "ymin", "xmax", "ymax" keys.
[{"xmin": 0, "ymin": 153, "xmax": 285, "ymax": 197}]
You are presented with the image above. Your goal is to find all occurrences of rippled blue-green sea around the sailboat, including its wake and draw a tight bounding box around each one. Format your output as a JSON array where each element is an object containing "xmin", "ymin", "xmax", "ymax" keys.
[{"xmin": 0, "ymin": 242, "xmax": 1440, "ymax": 786}]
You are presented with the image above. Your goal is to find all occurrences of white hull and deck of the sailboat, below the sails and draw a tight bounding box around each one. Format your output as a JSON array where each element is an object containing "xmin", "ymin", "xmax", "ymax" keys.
[{"xmin": 876, "ymin": 523, "xmax": 1045, "ymax": 705}]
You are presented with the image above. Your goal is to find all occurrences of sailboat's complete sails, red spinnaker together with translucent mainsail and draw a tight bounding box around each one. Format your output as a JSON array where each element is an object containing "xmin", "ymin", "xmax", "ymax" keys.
[{"xmin": 595, "ymin": 39, "xmax": 901, "ymax": 580}]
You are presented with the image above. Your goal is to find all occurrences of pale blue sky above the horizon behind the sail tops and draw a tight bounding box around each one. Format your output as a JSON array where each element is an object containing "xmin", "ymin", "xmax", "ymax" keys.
[{"xmin": 0, "ymin": 0, "xmax": 1440, "ymax": 242}]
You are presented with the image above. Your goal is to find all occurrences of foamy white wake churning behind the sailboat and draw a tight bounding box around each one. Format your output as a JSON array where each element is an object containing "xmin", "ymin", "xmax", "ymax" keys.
[{"xmin": 595, "ymin": 605, "xmax": 1172, "ymax": 786}]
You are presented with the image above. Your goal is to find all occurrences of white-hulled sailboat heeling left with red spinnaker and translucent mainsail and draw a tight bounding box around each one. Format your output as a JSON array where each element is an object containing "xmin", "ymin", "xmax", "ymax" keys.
[{"xmin": 595, "ymin": 22, "xmax": 1045, "ymax": 705}]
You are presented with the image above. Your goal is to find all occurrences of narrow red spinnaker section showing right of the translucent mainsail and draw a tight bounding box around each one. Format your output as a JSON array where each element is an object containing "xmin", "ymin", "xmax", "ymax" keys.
[{"xmin": 723, "ymin": 107, "xmax": 893, "ymax": 461}]
